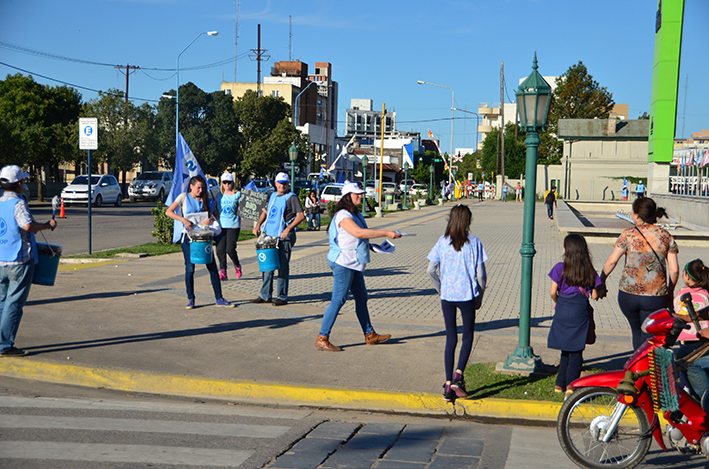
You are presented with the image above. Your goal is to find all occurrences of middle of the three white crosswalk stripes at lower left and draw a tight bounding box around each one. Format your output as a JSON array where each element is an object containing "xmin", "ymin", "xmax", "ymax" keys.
[{"xmin": 0, "ymin": 415, "xmax": 290, "ymax": 438}]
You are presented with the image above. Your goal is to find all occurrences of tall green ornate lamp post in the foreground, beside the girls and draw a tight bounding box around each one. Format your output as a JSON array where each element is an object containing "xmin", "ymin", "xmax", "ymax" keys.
[{"xmin": 502, "ymin": 52, "xmax": 551, "ymax": 373}]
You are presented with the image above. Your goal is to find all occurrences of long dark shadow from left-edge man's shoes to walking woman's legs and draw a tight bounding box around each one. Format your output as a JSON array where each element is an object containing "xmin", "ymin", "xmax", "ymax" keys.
[{"xmin": 25, "ymin": 315, "xmax": 322, "ymax": 355}]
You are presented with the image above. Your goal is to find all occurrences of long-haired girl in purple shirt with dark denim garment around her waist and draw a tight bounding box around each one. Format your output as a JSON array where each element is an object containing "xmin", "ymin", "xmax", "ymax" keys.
[{"xmin": 547, "ymin": 234, "xmax": 602, "ymax": 397}]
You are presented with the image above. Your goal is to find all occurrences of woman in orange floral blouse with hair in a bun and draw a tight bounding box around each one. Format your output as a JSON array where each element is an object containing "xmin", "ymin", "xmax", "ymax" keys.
[{"xmin": 601, "ymin": 197, "xmax": 679, "ymax": 349}]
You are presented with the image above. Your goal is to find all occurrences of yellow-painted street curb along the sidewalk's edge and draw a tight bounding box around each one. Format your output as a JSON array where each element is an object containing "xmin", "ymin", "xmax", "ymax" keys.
[{"xmin": 0, "ymin": 358, "xmax": 561, "ymax": 421}]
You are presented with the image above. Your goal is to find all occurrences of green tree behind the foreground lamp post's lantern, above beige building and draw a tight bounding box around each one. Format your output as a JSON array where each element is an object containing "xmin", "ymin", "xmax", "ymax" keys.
[{"xmin": 539, "ymin": 61, "xmax": 615, "ymax": 164}]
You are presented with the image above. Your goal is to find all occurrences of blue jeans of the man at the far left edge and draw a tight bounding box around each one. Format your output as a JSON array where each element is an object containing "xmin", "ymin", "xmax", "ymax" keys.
[{"xmin": 0, "ymin": 261, "xmax": 34, "ymax": 352}]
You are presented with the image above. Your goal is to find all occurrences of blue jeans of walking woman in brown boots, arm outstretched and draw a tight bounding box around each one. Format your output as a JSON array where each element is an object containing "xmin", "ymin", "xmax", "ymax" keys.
[{"xmin": 320, "ymin": 261, "xmax": 374, "ymax": 337}]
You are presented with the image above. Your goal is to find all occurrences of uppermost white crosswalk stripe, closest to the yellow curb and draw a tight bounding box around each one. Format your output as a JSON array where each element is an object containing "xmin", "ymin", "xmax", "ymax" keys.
[{"xmin": 0, "ymin": 396, "xmax": 312, "ymax": 420}]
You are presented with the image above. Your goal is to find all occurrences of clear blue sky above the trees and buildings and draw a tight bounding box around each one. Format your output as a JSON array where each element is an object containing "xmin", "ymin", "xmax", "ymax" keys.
[{"xmin": 0, "ymin": 0, "xmax": 709, "ymax": 150}]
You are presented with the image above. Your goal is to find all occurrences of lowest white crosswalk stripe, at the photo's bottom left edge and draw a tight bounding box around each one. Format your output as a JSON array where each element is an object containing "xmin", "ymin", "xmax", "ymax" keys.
[{"xmin": 0, "ymin": 440, "xmax": 254, "ymax": 467}]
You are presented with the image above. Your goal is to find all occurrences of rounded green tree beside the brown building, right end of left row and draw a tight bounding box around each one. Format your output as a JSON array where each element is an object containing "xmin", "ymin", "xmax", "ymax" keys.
[{"xmin": 234, "ymin": 91, "xmax": 303, "ymax": 180}]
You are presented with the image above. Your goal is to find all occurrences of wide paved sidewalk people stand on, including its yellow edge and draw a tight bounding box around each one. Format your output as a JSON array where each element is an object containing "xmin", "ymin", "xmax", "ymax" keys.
[{"xmin": 0, "ymin": 200, "xmax": 709, "ymax": 420}]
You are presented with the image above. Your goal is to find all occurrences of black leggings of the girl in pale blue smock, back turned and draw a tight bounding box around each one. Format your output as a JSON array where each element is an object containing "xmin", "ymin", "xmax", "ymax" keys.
[{"xmin": 441, "ymin": 300, "xmax": 475, "ymax": 381}]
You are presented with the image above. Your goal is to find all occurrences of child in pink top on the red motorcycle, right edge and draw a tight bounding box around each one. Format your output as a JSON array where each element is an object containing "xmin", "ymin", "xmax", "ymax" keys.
[{"xmin": 674, "ymin": 259, "xmax": 709, "ymax": 398}]
